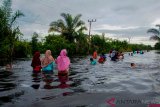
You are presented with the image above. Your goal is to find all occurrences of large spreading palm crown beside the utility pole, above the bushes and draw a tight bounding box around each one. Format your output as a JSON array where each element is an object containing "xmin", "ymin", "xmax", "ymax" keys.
[{"xmin": 49, "ymin": 13, "xmax": 87, "ymax": 42}]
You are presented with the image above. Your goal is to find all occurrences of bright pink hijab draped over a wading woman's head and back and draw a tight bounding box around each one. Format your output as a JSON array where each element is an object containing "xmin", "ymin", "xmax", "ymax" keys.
[{"xmin": 56, "ymin": 49, "xmax": 70, "ymax": 71}]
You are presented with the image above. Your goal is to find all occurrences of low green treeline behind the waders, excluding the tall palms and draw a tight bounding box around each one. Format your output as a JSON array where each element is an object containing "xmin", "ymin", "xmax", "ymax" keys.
[{"xmin": 14, "ymin": 33, "xmax": 153, "ymax": 57}]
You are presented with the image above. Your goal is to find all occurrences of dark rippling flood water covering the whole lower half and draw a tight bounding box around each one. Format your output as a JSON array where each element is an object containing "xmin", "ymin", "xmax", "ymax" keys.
[{"xmin": 0, "ymin": 51, "xmax": 160, "ymax": 107}]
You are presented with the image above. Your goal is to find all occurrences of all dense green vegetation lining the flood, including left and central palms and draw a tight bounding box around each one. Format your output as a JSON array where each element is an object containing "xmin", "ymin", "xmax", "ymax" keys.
[{"xmin": 0, "ymin": 0, "xmax": 156, "ymax": 65}]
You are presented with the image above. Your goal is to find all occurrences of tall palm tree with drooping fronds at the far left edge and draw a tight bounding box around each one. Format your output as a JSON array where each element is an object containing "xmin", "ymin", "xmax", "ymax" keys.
[{"xmin": 0, "ymin": 0, "xmax": 24, "ymax": 65}]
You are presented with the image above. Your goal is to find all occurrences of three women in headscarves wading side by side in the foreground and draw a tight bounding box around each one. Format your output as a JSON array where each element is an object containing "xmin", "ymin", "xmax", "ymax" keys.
[{"xmin": 31, "ymin": 49, "xmax": 70, "ymax": 88}]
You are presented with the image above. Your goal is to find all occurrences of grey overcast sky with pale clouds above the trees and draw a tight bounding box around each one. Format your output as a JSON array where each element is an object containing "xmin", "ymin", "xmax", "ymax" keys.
[{"xmin": 1, "ymin": 0, "xmax": 160, "ymax": 44}]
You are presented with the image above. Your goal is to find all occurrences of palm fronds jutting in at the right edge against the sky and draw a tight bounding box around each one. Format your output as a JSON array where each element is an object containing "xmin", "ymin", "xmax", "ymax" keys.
[{"xmin": 147, "ymin": 25, "xmax": 160, "ymax": 41}]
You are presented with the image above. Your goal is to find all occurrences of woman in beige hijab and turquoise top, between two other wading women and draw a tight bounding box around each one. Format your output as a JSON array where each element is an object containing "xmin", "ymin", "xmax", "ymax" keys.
[{"xmin": 41, "ymin": 50, "xmax": 54, "ymax": 72}]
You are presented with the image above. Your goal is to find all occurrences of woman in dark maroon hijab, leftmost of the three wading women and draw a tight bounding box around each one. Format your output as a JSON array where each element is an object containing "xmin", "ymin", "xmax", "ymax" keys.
[{"xmin": 31, "ymin": 51, "xmax": 41, "ymax": 72}]
